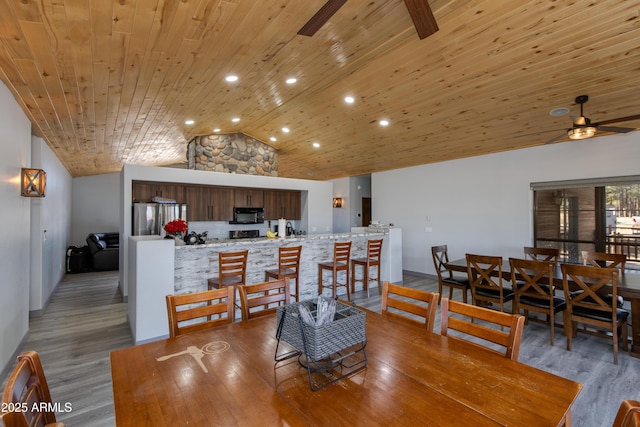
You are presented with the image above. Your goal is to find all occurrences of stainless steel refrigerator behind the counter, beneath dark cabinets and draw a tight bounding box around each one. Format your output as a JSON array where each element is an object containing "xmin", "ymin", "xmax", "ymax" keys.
[{"xmin": 131, "ymin": 203, "xmax": 187, "ymax": 236}]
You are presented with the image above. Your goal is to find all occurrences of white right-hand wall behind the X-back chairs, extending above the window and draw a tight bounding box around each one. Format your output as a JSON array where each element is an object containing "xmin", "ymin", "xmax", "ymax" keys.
[{"xmin": 372, "ymin": 132, "xmax": 640, "ymax": 274}]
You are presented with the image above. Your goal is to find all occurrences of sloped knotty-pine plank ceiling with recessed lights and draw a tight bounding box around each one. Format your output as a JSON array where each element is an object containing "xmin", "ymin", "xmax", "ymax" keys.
[{"xmin": 0, "ymin": 0, "xmax": 640, "ymax": 180}]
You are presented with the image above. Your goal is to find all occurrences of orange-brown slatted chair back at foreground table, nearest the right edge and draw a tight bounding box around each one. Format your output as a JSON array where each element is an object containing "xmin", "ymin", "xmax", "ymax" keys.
[{"xmin": 440, "ymin": 298, "xmax": 524, "ymax": 361}]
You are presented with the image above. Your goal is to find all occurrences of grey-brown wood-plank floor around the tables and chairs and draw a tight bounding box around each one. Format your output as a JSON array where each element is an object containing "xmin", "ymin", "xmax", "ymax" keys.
[{"xmin": 2, "ymin": 272, "xmax": 640, "ymax": 427}]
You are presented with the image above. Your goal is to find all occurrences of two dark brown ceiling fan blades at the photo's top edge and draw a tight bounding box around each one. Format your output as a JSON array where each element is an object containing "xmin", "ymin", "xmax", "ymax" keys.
[{"xmin": 298, "ymin": 0, "xmax": 438, "ymax": 40}]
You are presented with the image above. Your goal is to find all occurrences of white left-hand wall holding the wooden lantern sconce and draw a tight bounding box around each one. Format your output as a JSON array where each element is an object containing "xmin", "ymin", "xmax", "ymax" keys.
[{"xmin": 0, "ymin": 83, "xmax": 71, "ymax": 373}]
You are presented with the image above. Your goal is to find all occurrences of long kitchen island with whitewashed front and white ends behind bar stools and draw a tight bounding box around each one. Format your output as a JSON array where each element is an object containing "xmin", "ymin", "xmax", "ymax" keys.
[{"xmin": 129, "ymin": 228, "xmax": 402, "ymax": 344}]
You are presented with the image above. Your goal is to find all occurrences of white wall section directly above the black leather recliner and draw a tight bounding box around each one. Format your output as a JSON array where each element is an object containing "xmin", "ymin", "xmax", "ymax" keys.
[{"xmin": 71, "ymin": 173, "xmax": 124, "ymax": 246}]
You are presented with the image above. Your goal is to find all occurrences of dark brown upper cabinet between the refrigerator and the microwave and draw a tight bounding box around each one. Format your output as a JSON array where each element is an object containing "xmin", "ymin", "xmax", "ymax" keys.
[{"xmin": 186, "ymin": 185, "xmax": 233, "ymax": 221}]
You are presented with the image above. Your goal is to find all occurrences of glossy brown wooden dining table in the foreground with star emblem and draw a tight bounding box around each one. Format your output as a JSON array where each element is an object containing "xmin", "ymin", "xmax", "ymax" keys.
[{"xmin": 111, "ymin": 310, "xmax": 582, "ymax": 427}]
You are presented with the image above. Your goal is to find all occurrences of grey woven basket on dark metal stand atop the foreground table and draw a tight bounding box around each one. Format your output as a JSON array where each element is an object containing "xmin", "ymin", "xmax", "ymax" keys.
[{"xmin": 275, "ymin": 296, "xmax": 367, "ymax": 391}]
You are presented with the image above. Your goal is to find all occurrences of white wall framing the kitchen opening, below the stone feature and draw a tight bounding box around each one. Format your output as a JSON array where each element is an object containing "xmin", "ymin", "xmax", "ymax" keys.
[{"xmin": 120, "ymin": 165, "xmax": 333, "ymax": 296}]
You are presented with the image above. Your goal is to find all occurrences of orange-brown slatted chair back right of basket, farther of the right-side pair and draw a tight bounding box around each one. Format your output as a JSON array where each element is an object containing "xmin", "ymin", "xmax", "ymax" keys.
[{"xmin": 382, "ymin": 282, "xmax": 440, "ymax": 331}]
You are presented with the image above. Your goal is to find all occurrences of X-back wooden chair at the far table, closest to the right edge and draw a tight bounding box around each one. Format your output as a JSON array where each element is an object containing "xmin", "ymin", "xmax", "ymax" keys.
[{"xmin": 560, "ymin": 264, "xmax": 629, "ymax": 364}]
